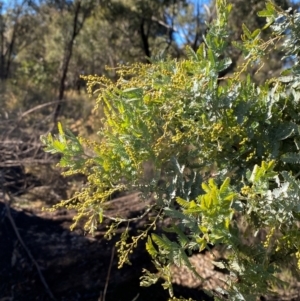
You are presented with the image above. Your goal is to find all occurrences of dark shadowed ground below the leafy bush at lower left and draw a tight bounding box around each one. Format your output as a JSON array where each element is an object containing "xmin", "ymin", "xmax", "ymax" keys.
[{"xmin": 0, "ymin": 191, "xmax": 216, "ymax": 301}]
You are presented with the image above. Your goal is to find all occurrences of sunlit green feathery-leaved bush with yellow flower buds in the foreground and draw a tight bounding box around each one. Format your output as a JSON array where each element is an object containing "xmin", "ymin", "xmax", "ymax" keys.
[{"xmin": 42, "ymin": 0, "xmax": 300, "ymax": 300}]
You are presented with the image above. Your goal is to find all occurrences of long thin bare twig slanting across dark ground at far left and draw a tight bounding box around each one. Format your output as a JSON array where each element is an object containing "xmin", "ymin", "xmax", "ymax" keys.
[{"xmin": 3, "ymin": 191, "xmax": 57, "ymax": 301}]
